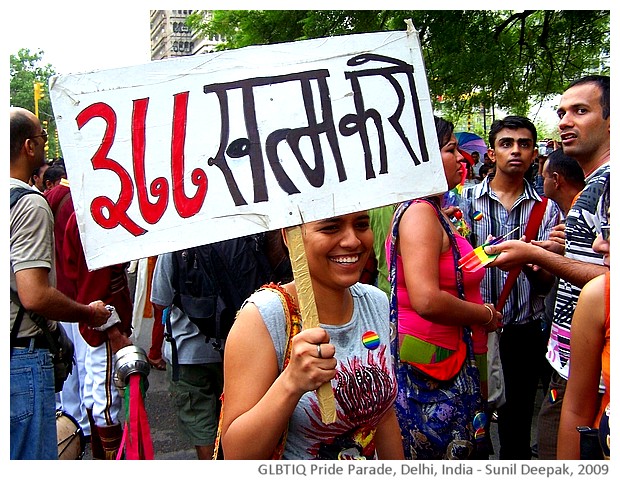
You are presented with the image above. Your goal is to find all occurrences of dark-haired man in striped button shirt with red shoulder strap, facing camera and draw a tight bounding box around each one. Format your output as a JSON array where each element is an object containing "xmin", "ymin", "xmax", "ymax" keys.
[{"xmin": 463, "ymin": 116, "xmax": 559, "ymax": 460}]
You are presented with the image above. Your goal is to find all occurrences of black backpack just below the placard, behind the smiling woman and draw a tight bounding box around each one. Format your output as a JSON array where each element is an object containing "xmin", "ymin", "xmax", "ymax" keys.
[{"xmin": 172, "ymin": 232, "xmax": 292, "ymax": 353}]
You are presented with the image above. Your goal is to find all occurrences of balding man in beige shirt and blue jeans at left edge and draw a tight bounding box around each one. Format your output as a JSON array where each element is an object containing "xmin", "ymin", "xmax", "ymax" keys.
[{"xmin": 9, "ymin": 107, "xmax": 110, "ymax": 460}]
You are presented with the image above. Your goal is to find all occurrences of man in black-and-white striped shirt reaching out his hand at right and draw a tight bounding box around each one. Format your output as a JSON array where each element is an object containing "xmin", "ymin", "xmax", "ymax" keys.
[{"xmin": 485, "ymin": 75, "xmax": 611, "ymax": 460}]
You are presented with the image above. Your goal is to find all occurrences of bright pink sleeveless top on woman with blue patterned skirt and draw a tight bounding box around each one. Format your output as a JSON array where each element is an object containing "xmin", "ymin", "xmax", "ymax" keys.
[{"xmin": 385, "ymin": 234, "xmax": 487, "ymax": 355}]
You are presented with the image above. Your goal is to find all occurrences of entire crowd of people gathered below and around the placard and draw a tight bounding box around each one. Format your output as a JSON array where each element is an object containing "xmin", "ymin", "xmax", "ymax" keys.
[{"xmin": 10, "ymin": 75, "xmax": 610, "ymax": 460}]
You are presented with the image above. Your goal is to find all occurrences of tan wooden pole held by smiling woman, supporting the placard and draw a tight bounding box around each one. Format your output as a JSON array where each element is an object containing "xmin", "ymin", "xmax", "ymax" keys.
[{"xmin": 286, "ymin": 225, "xmax": 336, "ymax": 423}]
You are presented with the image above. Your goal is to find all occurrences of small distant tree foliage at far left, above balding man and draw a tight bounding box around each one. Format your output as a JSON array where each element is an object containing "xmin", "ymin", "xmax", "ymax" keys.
[{"xmin": 9, "ymin": 48, "xmax": 60, "ymax": 157}]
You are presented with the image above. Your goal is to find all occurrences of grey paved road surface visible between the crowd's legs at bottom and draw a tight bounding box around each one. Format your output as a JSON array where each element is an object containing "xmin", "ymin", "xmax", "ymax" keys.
[{"xmin": 84, "ymin": 319, "xmax": 543, "ymax": 460}]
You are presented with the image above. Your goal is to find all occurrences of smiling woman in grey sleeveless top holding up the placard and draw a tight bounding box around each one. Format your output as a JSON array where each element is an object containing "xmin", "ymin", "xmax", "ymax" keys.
[{"xmin": 216, "ymin": 211, "xmax": 403, "ymax": 459}]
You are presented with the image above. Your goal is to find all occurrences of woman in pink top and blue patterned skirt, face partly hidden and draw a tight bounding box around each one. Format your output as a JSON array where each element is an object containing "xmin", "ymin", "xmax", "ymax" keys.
[{"xmin": 386, "ymin": 117, "xmax": 502, "ymax": 460}]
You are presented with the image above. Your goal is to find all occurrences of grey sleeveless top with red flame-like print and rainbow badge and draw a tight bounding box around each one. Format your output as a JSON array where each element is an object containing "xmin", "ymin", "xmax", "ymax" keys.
[{"xmin": 247, "ymin": 283, "xmax": 397, "ymax": 459}]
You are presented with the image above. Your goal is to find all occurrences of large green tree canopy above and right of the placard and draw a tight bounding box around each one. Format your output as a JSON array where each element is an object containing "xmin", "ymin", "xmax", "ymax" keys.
[{"xmin": 188, "ymin": 10, "xmax": 610, "ymax": 133}]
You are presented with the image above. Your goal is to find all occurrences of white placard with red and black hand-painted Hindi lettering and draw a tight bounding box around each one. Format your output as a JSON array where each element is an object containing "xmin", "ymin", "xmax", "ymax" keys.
[{"xmin": 50, "ymin": 31, "xmax": 447, "ymax": 269}]
